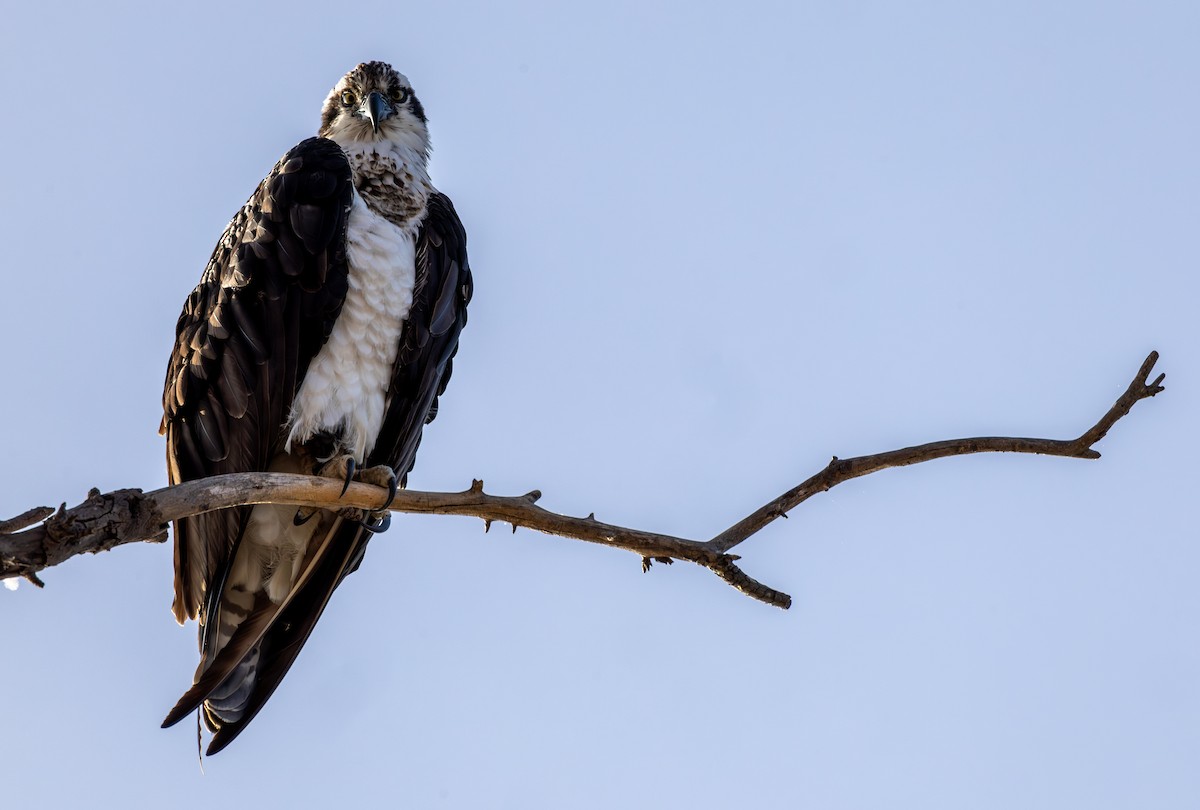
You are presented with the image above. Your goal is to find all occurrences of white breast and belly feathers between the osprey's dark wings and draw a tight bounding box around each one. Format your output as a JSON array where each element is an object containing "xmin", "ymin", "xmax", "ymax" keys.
[{"xmin": 287, "ymin": 191, "xmax": 416, "ymax": 463}]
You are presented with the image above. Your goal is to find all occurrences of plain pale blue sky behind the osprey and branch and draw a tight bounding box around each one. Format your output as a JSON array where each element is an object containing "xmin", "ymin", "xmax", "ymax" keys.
[{"xmin": 0, "ymin": 0, "xmax": 1200, "ymax": 810}]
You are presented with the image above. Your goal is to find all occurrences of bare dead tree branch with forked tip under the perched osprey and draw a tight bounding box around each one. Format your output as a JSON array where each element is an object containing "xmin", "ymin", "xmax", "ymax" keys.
[{"xmin": 0, "ymin": 352, "xmax": 1165, "ymax": 608}]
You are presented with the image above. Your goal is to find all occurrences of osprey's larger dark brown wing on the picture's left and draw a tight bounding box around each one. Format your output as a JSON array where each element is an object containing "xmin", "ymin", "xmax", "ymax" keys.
[{"xmin": 161, "ymin": 138, "xmax": 353, "ymax": 623}]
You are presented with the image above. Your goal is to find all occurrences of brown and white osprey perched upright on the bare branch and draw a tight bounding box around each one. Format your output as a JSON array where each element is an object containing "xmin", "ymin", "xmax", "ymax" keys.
[{"xmin": 160, "ymin": 62, "xmax": 472, "ymax": 754}]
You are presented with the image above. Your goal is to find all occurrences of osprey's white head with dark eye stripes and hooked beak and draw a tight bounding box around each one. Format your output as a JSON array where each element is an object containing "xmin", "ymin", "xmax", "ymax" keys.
[{"xmin": 318, "ymin": 62, "xmax": 430, "ymax": 152}]
